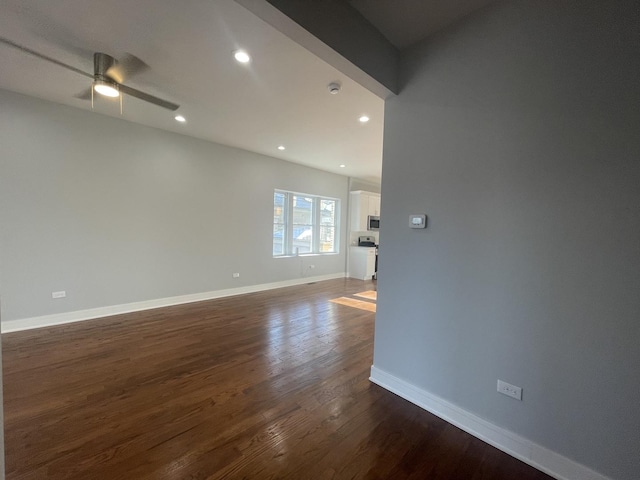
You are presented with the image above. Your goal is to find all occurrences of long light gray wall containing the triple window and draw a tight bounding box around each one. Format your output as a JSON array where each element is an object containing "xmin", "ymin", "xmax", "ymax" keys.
[{"xmin": 0, "ymin": 91, "xmax": 348, "ymax": 322}]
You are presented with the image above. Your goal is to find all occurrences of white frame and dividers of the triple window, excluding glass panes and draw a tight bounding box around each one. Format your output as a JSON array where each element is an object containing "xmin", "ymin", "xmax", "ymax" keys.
[{"xmin": 271, "ymin": 188, "xmax": 340, "ymax": 258}]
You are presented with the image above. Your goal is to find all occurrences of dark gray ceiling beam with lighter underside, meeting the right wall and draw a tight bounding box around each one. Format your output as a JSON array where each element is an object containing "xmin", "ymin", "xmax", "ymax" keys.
[{"xmin": 235, "ymin": 0, "xmax": 399, "ymax": 99}]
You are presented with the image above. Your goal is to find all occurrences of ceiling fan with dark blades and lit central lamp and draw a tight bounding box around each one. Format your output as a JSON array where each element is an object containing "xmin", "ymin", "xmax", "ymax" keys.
[{"xmin": 0, "ymin": 37, "xmax": 180, "ymax": 111}]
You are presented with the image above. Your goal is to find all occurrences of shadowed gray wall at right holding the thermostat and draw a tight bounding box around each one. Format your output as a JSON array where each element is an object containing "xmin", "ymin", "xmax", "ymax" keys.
[{"xmin": 374, "ymin": 0, "xmax": 640, "ymax": 480}]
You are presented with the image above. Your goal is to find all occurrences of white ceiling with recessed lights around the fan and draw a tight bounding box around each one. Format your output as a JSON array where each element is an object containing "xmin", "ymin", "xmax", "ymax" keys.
[{"xmin": 0, "ymin": 0, "xmax": 384, "ymax": 183}]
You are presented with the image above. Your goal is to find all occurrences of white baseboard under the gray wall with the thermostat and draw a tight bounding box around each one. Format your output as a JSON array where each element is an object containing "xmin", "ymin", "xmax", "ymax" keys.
[{"xmin": 369, "ymin": 365, "xmax": 611, "ymax": 480}]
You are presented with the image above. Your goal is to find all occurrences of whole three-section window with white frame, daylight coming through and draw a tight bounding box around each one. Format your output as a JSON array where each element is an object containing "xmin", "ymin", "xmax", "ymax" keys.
[{"xmin": 273, "ymin": 190, "xmax": 340, "ymax": 257}]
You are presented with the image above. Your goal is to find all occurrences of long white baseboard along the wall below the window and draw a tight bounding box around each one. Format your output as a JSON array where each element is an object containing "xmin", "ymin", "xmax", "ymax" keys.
[{"xmin": 2, "ymin": 272, "xmax": 345, "ymax": 333}]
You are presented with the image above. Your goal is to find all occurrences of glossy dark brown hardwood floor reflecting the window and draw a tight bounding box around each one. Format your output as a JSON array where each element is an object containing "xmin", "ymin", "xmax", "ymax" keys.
[{"xmin": 2, "ymin": 279, "xmax": 551, "ymax": 480}]
